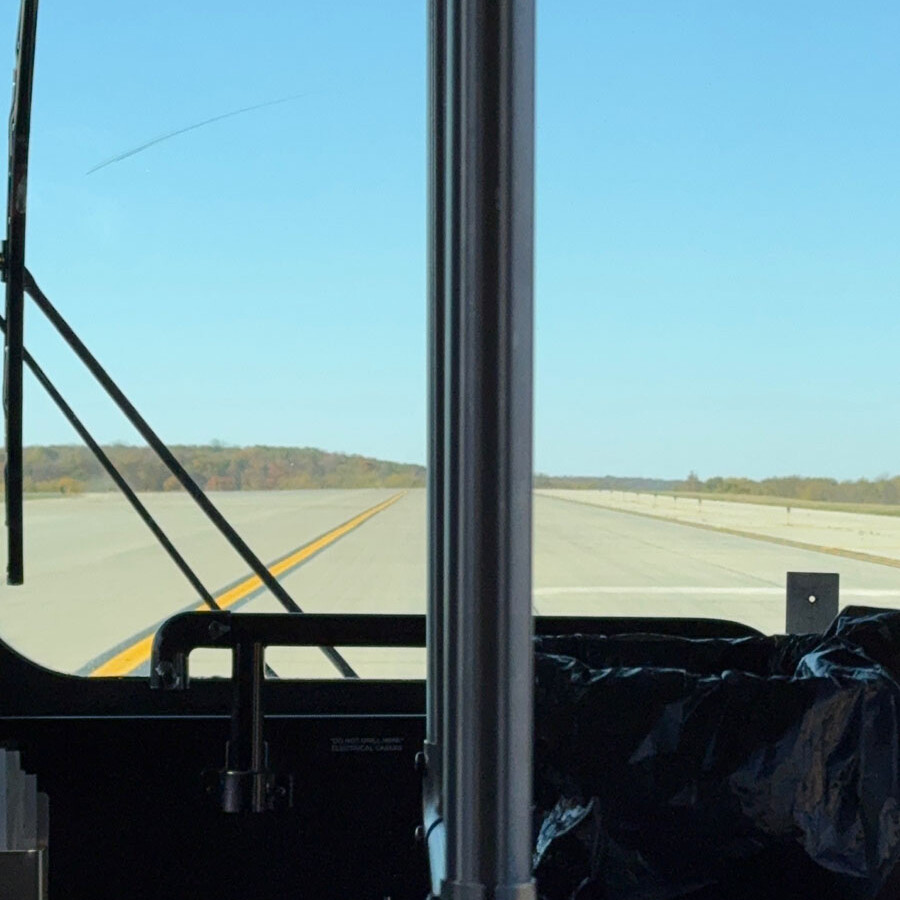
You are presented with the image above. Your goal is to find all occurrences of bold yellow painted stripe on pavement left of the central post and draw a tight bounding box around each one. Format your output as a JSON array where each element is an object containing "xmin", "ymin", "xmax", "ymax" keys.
[{"xmin": 81, "ymin": 491, "xmax": 408, "ymax": 678}]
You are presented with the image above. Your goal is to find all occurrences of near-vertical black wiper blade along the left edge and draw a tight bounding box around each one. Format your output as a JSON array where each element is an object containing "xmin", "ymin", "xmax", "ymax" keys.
[{"xmin": 2, "ymin": 0, "xmax": 38, "ymax": 584}]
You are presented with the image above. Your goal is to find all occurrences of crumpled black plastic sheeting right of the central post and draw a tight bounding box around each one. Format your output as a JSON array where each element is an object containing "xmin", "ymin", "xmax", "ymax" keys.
[{"xmin": 534, "ymin": 608, "xmax": 900, "ymax": 900}]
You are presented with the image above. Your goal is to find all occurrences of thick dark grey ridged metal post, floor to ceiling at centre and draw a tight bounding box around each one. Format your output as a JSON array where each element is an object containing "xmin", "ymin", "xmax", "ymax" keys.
[{"xmin": 441, "ymin": 0, "xmax": 535, "ymax": 900}]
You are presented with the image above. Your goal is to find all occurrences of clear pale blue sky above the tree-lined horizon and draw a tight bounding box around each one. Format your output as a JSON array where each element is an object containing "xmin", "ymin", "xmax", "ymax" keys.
[{"xmin": 12, "ymin": 0, "xmax": 900, "ymax": 477}]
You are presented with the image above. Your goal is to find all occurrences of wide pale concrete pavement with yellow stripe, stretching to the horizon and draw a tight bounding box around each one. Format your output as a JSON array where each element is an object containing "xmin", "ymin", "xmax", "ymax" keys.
[{"xmin": 0, "ymin": 490, "xmax": 900, "ymax": 677}]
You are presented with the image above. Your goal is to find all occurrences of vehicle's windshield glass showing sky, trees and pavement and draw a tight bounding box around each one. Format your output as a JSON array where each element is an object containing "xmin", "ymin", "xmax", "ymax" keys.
[{"xmin": 0, "ymin": 0, "xmax": 900, "ymax": 677}]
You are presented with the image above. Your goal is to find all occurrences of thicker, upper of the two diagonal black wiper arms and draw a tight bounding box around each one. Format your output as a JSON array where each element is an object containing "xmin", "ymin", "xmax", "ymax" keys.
[{"xmin": 25, "ymin": 269, "xmax": 357, "ymax": 678}]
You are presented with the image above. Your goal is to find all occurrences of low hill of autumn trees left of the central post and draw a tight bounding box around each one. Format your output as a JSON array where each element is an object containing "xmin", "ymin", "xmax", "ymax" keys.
[{"xmin": 0, "ymin": 444, "xmax": 425, "ymax": 494}]
